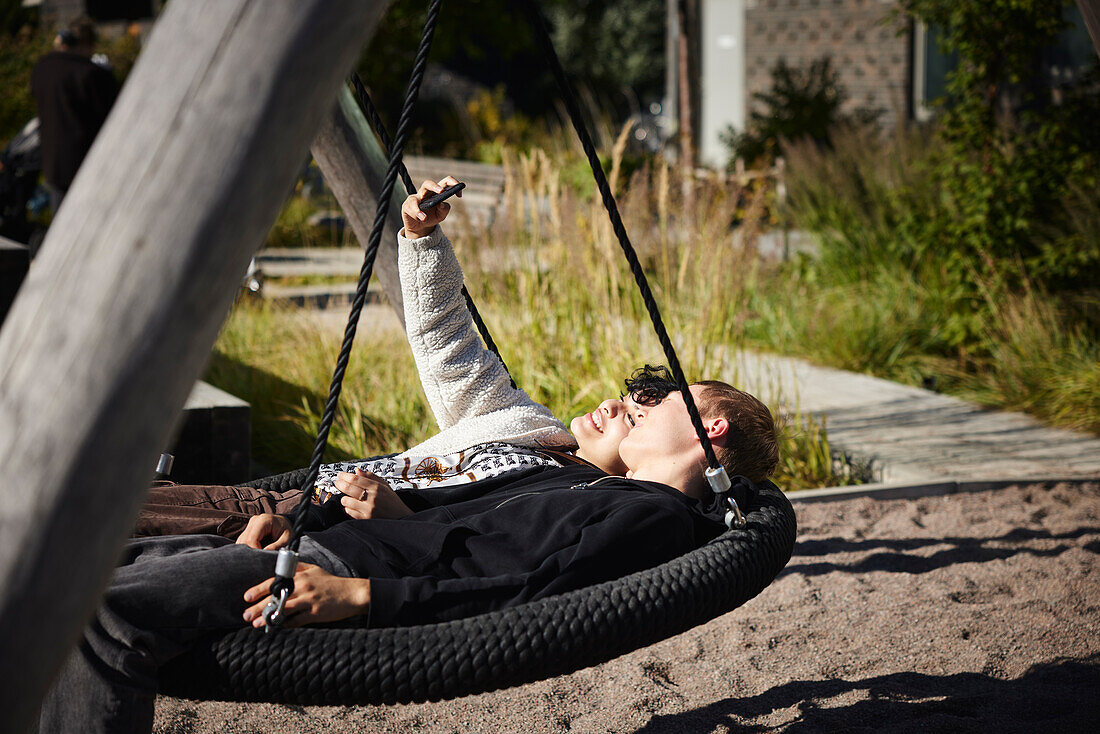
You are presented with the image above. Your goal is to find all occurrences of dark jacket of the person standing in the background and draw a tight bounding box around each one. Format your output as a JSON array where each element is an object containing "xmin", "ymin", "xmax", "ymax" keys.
[{"xmin": 31, "ymin": 51, "xmax": 119, "ymax": 191}]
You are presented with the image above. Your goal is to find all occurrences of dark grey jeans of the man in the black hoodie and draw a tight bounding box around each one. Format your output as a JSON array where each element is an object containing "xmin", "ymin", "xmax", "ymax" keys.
[{"xmin": 39, "ymin": 535, "xmax": 354, "ymax": 734}]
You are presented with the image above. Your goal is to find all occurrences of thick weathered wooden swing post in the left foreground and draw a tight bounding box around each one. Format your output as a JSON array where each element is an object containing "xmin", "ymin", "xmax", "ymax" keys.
[{"xmin": 0, "ymin": 0, "xmax": 388, "ymax": 732}]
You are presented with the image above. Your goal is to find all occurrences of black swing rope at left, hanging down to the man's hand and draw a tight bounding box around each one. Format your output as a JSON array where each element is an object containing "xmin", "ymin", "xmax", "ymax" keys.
[{"xmin": 289, "ymin": 0, "xmax": 442, "ymax": 551}]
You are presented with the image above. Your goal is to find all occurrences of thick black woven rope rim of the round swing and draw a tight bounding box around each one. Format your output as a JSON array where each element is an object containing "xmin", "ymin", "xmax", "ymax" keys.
[{"xmin": 160, "ymin": 470, "xmax": 795, "ymax": 705}]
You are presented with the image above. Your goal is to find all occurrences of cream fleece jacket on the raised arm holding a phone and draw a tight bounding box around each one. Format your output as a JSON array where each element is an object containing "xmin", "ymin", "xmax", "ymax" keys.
[{"xmin": 397, "ymin": 227, "xmax": 576, "ymax": 457}]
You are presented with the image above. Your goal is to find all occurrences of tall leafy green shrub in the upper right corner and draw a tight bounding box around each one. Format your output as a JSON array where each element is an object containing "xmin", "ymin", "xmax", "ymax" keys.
[{"xmin": 901, "ymin": 0, "xmax": 1100, "ymax": 288}]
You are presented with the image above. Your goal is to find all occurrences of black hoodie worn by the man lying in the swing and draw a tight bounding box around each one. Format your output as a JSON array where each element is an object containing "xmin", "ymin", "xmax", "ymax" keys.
[{"xmin": 307, "ymin": 465, "xmax": 725, "ymax": 627}]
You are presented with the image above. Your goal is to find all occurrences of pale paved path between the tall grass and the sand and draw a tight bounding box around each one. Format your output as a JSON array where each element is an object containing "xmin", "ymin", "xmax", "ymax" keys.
[{"xmin": 729, "ymin": 352, "xmax": 1100, "ymax": 484}]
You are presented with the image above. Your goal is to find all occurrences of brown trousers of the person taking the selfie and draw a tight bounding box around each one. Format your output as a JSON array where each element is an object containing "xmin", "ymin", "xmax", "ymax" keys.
[{"xmin": 133, "ymin": 483, "xmax": 312, "ymax": 539}]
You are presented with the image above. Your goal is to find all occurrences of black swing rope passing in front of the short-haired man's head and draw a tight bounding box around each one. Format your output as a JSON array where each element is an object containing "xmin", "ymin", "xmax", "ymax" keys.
[{"xmin": 523, "ymin": 0, "xmax": 721, "ymax": 469}]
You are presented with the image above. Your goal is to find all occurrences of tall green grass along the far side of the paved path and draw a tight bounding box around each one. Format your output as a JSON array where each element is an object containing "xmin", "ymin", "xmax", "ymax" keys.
[{"xmin": 783, "ymin": 123, "xmax": 1100, "ymax": 432}]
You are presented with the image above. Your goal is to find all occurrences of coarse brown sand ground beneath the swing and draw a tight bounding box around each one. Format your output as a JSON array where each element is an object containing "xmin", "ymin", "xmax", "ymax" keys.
[{"xmin": 155, "ymin": 483, "xmax": 1100, "ymax": 734}]
